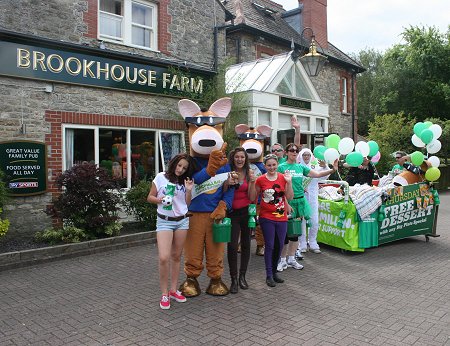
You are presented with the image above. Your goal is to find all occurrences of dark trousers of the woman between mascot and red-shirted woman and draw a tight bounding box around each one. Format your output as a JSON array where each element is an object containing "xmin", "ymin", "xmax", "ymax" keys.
[{"xmin": 227, "ymin": 207, "xmax": 250, "ymax": 276}]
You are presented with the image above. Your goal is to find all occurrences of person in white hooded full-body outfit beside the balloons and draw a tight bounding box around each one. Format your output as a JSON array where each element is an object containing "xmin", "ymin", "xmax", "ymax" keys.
[{"xmin": 297, "ymin": 148, "xmax": 328, "ymax": 253}]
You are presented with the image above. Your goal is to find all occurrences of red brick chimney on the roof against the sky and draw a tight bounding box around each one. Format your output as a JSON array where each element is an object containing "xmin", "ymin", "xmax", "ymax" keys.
[{"xmin": 298, "ymin": 0, "xmax": 328, "ymax": 49}]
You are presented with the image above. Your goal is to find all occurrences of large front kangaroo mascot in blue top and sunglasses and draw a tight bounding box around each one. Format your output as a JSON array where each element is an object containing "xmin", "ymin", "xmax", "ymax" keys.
[{"xmin": 178, "ymin": 98, "xmax": 234, "ymax": 297}]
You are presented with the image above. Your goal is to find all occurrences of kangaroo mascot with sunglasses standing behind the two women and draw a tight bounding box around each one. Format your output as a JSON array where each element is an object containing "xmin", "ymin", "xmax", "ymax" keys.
[{"xmin": 234, "ymin": 124, "xmax": 272, "ymax": 256}]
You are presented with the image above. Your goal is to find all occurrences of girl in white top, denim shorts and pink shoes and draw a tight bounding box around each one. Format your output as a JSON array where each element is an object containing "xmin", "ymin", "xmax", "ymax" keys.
[{"xmin": 147, "ymin": 154, "xmax": 194, "ymax": 309}]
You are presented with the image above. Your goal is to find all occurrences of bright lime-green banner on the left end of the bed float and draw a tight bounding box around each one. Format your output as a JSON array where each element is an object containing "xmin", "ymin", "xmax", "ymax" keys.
[{"xmin": 317, "ymin": 199, "xmax": 364, "ymax": 251}]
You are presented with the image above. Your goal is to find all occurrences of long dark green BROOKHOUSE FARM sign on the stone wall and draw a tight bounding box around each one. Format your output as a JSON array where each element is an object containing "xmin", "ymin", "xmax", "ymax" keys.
[{"xmin": 0, "ymin": 38, "xmax": 209, "ymax": 98}]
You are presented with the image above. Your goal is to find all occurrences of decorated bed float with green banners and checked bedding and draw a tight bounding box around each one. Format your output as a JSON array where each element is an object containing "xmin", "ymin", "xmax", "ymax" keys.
[{"xmin": 317, "ymin": 180, "xmax": 439, "ymax": 252}]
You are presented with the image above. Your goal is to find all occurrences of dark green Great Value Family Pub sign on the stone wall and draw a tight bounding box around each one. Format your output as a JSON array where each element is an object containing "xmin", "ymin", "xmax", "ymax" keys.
[{"xmin": 0, "ymin": 141, "xmax": 47, "ymax": 196}]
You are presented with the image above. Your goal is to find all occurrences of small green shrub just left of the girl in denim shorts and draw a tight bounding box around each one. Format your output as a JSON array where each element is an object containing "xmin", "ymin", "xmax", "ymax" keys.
[{"xmin": 124, "ymin": 180, "xmax": 157, "ymax": 229}]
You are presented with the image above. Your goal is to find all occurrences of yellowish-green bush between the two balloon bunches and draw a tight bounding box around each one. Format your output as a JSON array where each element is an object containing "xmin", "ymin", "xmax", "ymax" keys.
[{"xmin": 368, "ymin": 113, "xmax": 417, "ymax": 176}]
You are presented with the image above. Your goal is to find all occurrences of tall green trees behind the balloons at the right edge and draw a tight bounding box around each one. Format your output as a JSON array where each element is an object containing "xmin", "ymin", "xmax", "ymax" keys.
[{"xmin": 355, "ymin": 26, "xmax": 450, "ymax": 135}]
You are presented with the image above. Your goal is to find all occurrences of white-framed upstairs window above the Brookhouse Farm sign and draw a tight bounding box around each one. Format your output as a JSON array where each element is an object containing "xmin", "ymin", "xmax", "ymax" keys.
[{"xmin": 97, "ymin": 0, "xmax": 158, "ymax": 52}]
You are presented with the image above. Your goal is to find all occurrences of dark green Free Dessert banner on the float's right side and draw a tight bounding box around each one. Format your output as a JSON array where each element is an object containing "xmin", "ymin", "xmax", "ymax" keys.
[{"xmin": 379, "ymin": 183, "xmax": 436, "ymax": 244}]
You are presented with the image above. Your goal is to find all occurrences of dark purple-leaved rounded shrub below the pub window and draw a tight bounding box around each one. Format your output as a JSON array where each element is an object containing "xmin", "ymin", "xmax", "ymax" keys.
[{"xmin": 47, "ymin": 163, "xmax": 121, "ymax": 239}]
